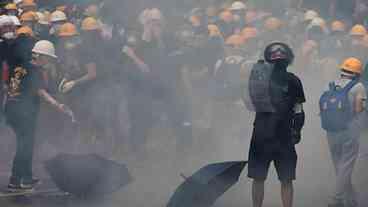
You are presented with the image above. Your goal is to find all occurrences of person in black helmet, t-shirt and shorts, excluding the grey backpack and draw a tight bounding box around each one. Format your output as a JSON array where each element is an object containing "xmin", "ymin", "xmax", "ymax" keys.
[{"xmin": 248, "ymin": 43, "xmax": 305, "ymax": 207}]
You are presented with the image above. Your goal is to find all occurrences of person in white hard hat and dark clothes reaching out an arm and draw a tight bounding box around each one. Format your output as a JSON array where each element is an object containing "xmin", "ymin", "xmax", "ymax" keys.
[{"xmin": 5, "ymin": 41, "xmax": 73, "ymax": 191}]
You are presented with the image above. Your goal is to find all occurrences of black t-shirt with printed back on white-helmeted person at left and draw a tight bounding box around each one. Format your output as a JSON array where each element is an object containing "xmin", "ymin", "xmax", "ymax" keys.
[{"xmin": 8, "ymin": 64, "xmax": 45, "ymax": 111}]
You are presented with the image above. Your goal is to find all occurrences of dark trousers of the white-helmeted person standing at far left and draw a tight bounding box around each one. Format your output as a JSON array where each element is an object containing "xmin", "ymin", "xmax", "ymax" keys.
[{"xmin": 6, "ymin": 104, "xmax": 38, "ymax": 182}]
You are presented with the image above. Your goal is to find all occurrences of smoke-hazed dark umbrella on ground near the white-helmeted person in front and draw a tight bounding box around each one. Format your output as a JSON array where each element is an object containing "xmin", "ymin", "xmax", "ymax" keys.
[{"xmin": 45, "ymin": 154, "xmax": 132, "ymax": 197}]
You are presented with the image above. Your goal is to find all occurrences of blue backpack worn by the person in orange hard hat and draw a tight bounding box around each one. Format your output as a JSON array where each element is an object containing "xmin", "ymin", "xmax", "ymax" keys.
[{"xmin": 319, "ymin": 79, "xmax": 359, "ymax": 132}]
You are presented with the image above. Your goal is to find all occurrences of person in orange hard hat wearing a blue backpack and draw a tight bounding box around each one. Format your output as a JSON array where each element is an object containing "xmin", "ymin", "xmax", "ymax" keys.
[{"xmin": 320, "ymin": 57, "xmax": 367, "ymax": 207}]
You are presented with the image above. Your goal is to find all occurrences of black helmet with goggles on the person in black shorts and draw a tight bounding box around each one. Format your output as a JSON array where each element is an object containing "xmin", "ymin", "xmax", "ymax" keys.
[{"xmin": 264, "ymin": 42, "xmax": 294, "ymax": 64}]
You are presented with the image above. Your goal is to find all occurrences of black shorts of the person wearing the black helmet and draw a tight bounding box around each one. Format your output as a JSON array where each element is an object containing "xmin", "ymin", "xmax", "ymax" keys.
[{"xmin": 248, "ymin": 141, "xmax": 297, "ymax": 181}]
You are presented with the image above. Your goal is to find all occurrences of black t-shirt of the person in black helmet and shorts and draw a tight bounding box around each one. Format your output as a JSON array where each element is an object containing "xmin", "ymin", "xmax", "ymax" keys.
[{"xmin": 253, "ymin": 73, "xmax": 306, "ymax": 145}]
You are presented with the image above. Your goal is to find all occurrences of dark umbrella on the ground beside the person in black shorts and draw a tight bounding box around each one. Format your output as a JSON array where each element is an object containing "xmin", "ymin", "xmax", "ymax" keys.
[{"xmin": 167, "ymin": 161, "xmax": 247, "ymax": 207}]
